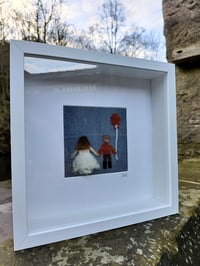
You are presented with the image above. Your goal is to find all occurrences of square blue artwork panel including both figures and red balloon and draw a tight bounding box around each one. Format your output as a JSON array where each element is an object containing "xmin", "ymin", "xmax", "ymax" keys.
[{"xmin": 63, "ymin": 106, "xmax": 128, "ymax": 177}]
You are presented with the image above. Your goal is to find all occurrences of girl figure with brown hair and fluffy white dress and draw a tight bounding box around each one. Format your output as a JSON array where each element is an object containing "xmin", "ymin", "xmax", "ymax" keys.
[{"xmin": 71, "ymin": 136, "xmax": 100, "ymax": 175}]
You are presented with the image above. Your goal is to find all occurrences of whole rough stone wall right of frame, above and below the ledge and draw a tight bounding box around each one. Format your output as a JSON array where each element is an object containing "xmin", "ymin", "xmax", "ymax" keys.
[{"xmin": 163, "ymin": 0, "xmax": 200, "ymax": 160}]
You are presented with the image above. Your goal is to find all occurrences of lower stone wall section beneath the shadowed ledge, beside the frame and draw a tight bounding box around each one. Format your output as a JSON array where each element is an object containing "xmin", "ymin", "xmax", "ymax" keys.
[{"xmin": 176, "ymin": 62, "xmax": 200, "ymax": 159}]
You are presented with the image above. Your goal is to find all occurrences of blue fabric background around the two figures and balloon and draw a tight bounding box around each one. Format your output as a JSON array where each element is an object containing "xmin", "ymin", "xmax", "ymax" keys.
[{"xmin": 63, "ymin": 106, "xmax": 128, "ymax": 177}]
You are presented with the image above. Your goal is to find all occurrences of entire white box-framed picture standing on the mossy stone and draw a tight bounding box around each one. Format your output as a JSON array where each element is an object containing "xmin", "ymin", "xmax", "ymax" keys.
[{"xmin": 10, "ymin": 41, "xmax": 178, "ymax": 250}]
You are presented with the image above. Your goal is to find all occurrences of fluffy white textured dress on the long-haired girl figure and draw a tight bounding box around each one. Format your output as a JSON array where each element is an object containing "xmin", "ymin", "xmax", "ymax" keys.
[{"xmin": 72, "ymin": 147, "xmax": 100, "ymax": 175}]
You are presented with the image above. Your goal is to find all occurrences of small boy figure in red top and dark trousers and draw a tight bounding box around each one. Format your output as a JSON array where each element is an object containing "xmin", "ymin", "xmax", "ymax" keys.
[{"xmin": 98, "ymin": 135, "xmax": 117, "ymax": 169}]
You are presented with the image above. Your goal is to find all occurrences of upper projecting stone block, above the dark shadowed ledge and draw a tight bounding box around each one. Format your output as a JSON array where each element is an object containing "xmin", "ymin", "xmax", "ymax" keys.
[{"xmin": 162, "ymin": 0, "xmax": 200, "ymax": 62}]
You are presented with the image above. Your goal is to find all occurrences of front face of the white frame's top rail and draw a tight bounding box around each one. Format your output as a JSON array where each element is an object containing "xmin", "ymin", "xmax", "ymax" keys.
[{"xmin": 12, "ymin": 40, "xmax": 174, "ymax": 72}]
